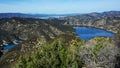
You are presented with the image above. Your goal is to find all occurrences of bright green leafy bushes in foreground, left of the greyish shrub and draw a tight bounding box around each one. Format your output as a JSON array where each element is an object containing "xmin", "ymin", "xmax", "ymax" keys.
[{"xmin": 15, "ymin": 35, "xmax": 83, "ymax": 68}]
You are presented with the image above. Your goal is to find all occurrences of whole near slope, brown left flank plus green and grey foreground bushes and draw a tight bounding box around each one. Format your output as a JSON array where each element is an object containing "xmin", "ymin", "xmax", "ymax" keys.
[{"xmin": 0, "ymin": 34, "xmax": 119, "ymax": 68}]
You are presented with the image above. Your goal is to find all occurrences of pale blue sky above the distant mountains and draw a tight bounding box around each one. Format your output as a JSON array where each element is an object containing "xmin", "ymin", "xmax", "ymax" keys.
[{"xmin": 0, "ymin": 0, "xmax": 120, "ymax": 14}]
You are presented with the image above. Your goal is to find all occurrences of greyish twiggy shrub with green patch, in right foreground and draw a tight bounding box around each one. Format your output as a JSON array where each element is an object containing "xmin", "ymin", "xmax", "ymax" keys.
[{"xmin": 79, "ymin": 39, "xmax": 119, "ymax": 68}]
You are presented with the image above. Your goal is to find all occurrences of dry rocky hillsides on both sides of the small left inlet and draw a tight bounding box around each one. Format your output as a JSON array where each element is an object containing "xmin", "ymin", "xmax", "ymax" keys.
[{"xmin": 0, "ymin": 18, "xmax": 74, "ymax": 68}]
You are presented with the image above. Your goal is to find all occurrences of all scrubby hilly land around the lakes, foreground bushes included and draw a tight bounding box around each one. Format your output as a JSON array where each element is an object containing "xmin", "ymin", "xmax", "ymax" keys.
[{"xmin": 0, "ymin": 11, "xmax": 120, "ymax": 68}]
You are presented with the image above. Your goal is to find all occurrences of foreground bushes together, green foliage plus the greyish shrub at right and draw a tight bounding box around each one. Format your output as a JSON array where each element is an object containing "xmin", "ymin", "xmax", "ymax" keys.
[{"xmin": 15, "ymin": 35, "xmax": 119, "ymax": 68}]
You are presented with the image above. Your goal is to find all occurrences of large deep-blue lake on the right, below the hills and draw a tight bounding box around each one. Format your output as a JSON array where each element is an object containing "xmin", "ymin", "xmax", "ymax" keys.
[{"xmin": 73, "ymin": 27, "xmax": 115, "ymax": 40}]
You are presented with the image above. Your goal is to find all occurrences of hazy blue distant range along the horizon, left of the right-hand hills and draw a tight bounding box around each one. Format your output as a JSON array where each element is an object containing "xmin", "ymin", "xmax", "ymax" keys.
[{"xmin": 0, "ymin": 13, "xmax": 77, "ymax": 18}]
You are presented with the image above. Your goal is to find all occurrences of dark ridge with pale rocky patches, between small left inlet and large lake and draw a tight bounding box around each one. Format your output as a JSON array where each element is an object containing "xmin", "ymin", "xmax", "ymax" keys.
[{"xmin": 0, "ymin": 18, "xmax": 74, "ymax": 43}]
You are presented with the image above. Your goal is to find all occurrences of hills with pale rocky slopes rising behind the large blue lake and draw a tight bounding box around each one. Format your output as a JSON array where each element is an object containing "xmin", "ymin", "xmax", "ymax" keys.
[{"xmin": 60, "ymin": 11, "xmax": 120, "ymax": 33}]
